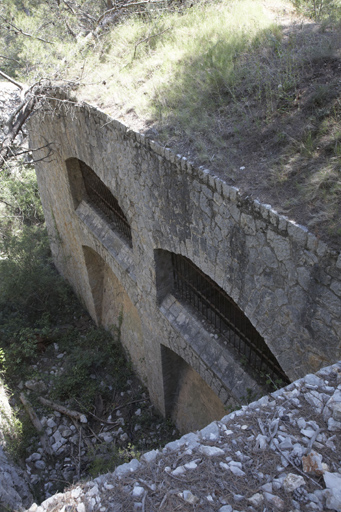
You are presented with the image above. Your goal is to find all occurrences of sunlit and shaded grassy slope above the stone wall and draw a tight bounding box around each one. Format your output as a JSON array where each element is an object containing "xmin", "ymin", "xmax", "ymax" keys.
[{"xmin": 0, "ymin": 0, "xmax": 341, "ymax": 247}]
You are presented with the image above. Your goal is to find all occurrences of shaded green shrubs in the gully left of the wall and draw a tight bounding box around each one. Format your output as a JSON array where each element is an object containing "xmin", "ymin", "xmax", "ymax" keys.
[{"xmin": 0, "ymin": 162, "xmax": 175, "ymax": 476}]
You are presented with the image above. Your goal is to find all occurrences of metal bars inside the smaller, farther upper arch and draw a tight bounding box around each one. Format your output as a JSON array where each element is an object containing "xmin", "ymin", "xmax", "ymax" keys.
[{"xmin": 81, "ymin": 162, "xmax": 132, "ymax": 246}]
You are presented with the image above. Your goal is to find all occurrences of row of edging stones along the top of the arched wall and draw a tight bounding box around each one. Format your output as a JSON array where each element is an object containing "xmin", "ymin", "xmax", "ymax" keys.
[{"xmin": 41, "ymin": 102, "xmax": 341, "ymax": 264}]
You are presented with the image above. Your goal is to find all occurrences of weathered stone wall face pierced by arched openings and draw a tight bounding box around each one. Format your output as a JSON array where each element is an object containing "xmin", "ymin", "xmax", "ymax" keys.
[{"xmin": 30, "ymin": 102, "xmax": 341, "ymax": 418}]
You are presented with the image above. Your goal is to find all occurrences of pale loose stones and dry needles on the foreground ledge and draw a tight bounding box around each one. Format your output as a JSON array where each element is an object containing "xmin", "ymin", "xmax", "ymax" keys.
[{"xmin": 25, "ymin": 362, "xmax": 341, "ymax": 512}]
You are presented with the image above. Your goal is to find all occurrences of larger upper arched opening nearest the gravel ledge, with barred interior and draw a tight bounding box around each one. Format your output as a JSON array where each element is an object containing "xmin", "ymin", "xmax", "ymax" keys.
[{"xmin": 156, "ymin": 250, "xmax": 290, "ymax": 383}]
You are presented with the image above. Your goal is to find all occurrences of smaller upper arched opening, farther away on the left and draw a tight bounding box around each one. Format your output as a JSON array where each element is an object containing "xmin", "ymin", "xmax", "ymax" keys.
[{"xmin": 66, "ymin": 158, "xmax": 132, "ymax": 246}]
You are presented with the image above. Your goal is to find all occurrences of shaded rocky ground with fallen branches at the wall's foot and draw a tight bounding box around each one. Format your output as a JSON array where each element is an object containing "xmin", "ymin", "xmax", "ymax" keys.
[{"xmin": 0, "ymin": 314, "xmax": 178, "ymax": 511}]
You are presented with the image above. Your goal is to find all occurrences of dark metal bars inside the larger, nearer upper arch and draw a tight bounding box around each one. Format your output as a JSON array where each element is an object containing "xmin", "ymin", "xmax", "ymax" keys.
[{"xmin": 172, "ymin": 253, "xmax": 290, "ymax": 383}]
